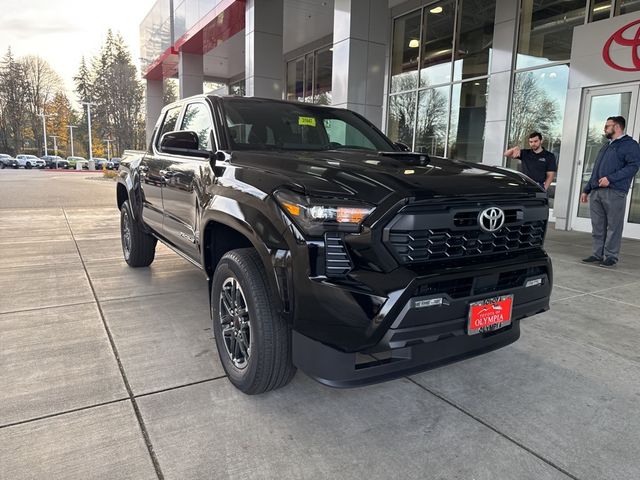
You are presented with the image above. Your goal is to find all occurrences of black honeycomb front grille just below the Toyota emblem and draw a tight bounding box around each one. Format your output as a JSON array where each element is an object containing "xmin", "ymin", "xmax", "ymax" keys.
[{"xmin": 389, "ymin": 219, "xmax": 546, "ymax": 264}]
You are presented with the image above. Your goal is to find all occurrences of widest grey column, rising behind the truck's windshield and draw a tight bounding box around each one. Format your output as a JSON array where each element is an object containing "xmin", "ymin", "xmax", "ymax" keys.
[{"xmin": 331, "ymin": 0, "xmax": 389, "ymax": 127}]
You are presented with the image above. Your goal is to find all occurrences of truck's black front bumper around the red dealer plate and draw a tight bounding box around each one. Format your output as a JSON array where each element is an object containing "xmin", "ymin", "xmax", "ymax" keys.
[{"xmin": 293, "ymin": 251, "xmax": 553, "ymax": 387}]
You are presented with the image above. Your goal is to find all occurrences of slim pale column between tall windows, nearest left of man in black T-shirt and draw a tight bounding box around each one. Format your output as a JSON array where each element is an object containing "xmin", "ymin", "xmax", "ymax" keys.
[{"xmin": 482, "ymin": 0, "xmax": 518, "ymax": 166}]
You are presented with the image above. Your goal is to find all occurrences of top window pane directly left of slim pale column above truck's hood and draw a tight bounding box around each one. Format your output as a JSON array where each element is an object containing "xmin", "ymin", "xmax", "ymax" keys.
[{"xmin": 453, "ymin": 0, "xmax": 496, "ymax": 80}]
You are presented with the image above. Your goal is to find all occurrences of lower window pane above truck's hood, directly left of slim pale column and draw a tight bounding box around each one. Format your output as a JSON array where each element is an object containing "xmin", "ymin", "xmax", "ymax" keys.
[{"xmin": 447, "ymin": 80, "xmax": 487, "ymax": 162}]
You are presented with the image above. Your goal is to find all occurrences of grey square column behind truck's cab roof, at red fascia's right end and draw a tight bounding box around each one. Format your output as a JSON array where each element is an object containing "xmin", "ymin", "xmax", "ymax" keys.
[{"xmin": 244, "ymin": 0, "xmax": 284, "ymax": 98}]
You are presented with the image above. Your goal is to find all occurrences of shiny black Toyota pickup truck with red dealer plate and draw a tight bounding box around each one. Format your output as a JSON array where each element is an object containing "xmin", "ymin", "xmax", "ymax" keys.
[{"xmin": 117, "ymin": 96, "xmax": 552, "ymax": 394}]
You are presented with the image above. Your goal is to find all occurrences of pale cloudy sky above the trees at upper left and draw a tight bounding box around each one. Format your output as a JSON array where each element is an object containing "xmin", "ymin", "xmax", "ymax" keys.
[{"xmin": 0, "ymin": 0, "xmax": 156, "ymax": 95}]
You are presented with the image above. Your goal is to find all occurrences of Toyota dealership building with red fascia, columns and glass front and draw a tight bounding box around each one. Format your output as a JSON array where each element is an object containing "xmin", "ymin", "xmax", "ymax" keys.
[{"xmin": 140, "ymin": 0, "xmax": 640, "ymax": 239}]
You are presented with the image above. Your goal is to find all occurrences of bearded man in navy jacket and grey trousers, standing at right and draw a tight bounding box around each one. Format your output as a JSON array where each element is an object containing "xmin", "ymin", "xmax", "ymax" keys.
[{"xmin": 580, "ymin": 117, "xmax": 640, "ymax": 267}]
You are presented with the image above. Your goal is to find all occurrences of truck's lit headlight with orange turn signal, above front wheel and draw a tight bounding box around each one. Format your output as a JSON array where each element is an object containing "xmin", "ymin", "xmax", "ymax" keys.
[{"xmin": 273, "ymin": 190, "xmax": 373, "ymax": 236}]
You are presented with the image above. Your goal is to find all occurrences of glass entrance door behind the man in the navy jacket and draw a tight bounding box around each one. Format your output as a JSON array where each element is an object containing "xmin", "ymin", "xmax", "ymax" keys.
[{"xmin": 572, "ymin": 83, "xmax": 640, "ymax": 238}]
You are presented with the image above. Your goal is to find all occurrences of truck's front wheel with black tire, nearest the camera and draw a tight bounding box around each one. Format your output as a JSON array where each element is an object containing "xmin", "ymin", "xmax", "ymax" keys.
[{"xmin": 211, "ymin": 248, "xmax": 296, "ymax": 395}]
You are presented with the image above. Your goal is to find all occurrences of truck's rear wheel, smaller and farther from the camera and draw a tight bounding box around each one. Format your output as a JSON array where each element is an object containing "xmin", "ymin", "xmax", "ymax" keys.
[{"xmin": 120, "ymin": 200, "xmax": 157, "ymax": 268}]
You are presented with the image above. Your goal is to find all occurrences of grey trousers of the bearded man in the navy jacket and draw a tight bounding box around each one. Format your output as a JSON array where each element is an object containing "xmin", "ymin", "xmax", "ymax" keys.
[{"xmin": 589, "ymin": 188, "xmax": 627, "ymax": 260}]
